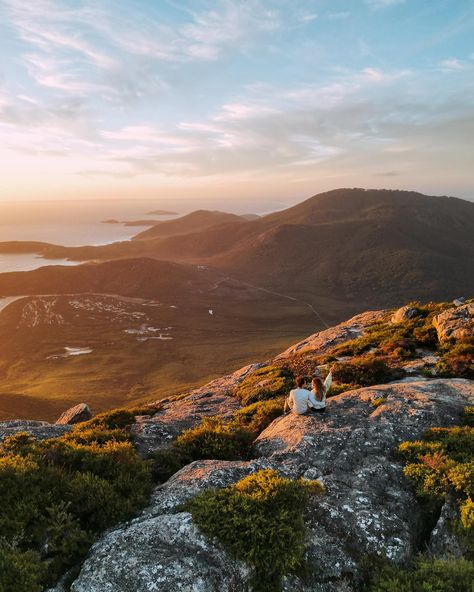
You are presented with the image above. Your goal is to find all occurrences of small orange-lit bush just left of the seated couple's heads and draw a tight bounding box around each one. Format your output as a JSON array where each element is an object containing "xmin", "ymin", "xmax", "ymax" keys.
[{"xmin": 235, "ymin": 366, "xmax": 293, "ymax": 405}]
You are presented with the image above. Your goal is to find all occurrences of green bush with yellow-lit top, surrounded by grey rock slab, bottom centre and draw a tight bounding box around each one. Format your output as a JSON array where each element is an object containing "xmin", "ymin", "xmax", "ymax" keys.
[{"xmin": 185, "ymin": 470, "xmax": 322, "ymax": 592}]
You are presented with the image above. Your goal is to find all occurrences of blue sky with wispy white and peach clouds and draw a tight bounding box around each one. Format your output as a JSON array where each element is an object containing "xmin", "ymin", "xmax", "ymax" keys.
[{"xmin": 0, "ymin": 0, "xmax": 474, "ymax": 203}]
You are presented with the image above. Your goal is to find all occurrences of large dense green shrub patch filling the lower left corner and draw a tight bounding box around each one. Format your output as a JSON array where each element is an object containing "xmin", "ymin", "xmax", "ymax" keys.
[{"xmin": 0, "ymin": 411, "xmax": 151, "ymax": 592}]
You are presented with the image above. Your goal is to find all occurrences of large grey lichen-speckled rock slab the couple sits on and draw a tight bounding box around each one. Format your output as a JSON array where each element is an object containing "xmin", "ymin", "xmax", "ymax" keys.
[{"xmin": 67, "ymin": 379, "xmax": 474, "ymax": 592}]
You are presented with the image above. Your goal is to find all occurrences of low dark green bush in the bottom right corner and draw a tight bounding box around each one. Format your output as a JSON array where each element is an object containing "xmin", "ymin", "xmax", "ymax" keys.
[{"xmin": 371, "ymin": 558, "xmax": 474, "ymax": 592}]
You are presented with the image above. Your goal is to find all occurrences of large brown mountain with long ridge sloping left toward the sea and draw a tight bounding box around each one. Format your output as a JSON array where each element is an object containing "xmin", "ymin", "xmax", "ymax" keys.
[{"xmin": 0, "ymin": 189, "xmax": 474, "ymax": 321}]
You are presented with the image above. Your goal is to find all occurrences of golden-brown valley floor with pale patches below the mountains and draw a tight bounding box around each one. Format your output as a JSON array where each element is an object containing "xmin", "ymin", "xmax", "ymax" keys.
[{"xmin": 0, "ymin": 276, "xmax": 318, "ymax": 420}]
